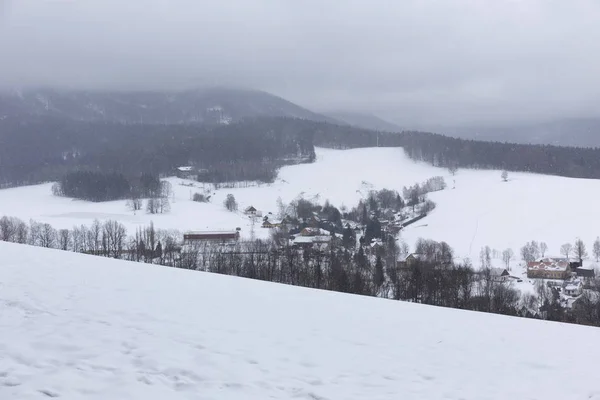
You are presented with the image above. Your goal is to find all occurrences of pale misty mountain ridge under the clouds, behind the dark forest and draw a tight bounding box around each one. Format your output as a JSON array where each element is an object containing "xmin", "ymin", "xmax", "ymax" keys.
[{"xmin": 0, "ymin": 87, "xmax": 334, "ymax": 124}]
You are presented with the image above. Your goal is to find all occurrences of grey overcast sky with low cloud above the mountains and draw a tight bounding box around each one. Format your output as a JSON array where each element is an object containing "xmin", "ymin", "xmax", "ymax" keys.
[{"xmin": 0, "ymin": 0, "xmax": 600, "ymax": 124}]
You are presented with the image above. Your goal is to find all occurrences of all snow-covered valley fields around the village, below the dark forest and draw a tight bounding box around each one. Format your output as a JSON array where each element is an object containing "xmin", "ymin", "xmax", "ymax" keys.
[{"xmin": 0, "ymin": 148, "xmax": 600, "ymax": 262}]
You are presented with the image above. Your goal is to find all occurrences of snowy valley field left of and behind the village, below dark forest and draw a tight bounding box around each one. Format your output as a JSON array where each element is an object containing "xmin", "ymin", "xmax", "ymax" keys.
[{"xmin": 0, "ymin": 149, "xmax": 439, "ymax": 241}]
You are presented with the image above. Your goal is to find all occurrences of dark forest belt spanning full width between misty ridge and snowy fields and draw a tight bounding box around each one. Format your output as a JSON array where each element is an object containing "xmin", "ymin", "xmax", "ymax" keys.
[{"xmin": 0, "ymin": 116, "xmax": 600, "ymax": 187}]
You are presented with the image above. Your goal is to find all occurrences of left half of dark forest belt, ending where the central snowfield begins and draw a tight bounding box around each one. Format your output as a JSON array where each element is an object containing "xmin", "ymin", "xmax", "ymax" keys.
[{"xmin": 0, "ymin": 117, "xmax": 314, "ymax": 186}]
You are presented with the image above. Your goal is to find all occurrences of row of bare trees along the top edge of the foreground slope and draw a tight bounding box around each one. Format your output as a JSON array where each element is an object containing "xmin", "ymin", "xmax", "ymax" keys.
[{"xmin": 0, "ymin": 212, "xmax": 600, "ymax": 325}]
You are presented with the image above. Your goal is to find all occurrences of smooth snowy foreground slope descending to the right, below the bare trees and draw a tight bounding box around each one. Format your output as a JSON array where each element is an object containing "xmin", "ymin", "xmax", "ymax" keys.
[{"xmin": 0, "ymin": 239, "xmax": 600, "ymax": 400}]
